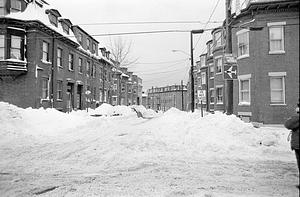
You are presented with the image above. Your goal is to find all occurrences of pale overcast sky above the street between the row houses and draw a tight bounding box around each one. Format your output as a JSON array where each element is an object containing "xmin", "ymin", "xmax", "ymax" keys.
[{"xmin": 48, "ymin": 0, "xmax": 225, "ymax": 90}]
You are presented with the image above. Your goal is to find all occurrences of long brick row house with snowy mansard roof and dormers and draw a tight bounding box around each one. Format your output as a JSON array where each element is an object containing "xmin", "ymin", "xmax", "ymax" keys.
[{"xmin": 0, "ymin": 0, "xmax": 141, "ymax": 112}]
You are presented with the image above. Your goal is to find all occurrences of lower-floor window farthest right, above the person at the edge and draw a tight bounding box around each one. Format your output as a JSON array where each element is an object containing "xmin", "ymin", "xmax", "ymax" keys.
[{"xmin": 269, "ymin": 72, "xmax": 286, "ymax": 104}]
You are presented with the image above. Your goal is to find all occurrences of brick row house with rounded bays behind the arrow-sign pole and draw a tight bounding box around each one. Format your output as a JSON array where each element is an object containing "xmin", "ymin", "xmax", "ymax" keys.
[{"xmin": 193, "ymin": 0, "xmax": 299, "ymax": 124}]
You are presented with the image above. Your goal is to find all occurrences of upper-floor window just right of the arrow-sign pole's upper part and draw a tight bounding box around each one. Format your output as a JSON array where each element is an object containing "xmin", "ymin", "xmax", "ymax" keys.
[{"xmin": 237, "ymin": 30, "xmax": 249, "ymax": 57}]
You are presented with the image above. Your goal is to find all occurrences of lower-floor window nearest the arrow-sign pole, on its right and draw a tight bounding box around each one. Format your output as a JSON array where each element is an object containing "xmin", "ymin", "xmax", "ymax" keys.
[{"xmin": 239, "ymin": 74, "xmax": 251, "ymax": 105}]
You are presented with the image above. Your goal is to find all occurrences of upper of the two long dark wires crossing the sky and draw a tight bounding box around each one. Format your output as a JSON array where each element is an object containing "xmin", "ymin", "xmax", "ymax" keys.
[{"xmin": 77, "ymin": 21, "xmax": 222, "ymax": 26}]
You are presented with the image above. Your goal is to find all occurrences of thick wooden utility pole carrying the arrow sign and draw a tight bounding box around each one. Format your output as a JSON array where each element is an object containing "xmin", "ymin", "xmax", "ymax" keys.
[{"xmin": 225, "ymin": 0, "xmax": 233, "ymax": 115}]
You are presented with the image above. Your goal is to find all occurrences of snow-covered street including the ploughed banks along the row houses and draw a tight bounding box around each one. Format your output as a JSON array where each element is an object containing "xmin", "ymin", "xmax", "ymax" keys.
[{"xmin": 0, "ymin": 102, "xmax": 299, "ymax": 197}]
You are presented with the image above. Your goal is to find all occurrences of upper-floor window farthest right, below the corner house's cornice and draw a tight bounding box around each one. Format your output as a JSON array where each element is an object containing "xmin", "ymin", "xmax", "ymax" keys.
[{"xmin": 268, "ymin": 22, "xmax": 286, "ymax": 53}]
